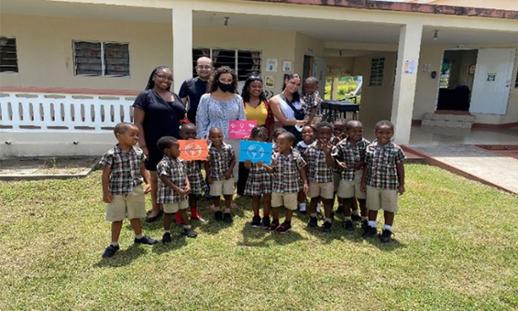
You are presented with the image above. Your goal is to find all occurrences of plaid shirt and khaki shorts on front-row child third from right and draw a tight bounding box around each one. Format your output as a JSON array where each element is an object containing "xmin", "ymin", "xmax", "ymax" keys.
[{"xmin": 304, "ymin": 142, "xmax": 334, "ymax": 199}]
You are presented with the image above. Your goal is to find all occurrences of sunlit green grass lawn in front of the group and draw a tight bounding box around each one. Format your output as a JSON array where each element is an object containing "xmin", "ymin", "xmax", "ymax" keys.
[{"xmin": 0, "ymin": 164, "xmax": 518, "ymax": 310}]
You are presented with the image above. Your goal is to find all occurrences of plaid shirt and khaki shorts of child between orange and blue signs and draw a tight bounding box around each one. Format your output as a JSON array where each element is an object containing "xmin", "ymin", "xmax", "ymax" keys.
[{"xmin": 208, "ymin": 142, "xmax": 236, "ymax": 196}]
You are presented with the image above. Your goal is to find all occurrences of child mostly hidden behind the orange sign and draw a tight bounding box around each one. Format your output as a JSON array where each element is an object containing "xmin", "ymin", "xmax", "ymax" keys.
[{"xmin": 176, "ymin": 123, "xmax": 207, "ymax": 225}]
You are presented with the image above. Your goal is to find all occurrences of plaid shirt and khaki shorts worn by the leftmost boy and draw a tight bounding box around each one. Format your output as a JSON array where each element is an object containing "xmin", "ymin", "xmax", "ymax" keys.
[{"xmin": 99, "ymin": 145, "xmax": 146, "ymax": 222}]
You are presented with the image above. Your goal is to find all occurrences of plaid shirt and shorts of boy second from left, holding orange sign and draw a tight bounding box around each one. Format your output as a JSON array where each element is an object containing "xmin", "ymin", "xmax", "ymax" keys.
[{"xmin": 156, "ymin": 156, "xmax": 189, "ymax": 214}]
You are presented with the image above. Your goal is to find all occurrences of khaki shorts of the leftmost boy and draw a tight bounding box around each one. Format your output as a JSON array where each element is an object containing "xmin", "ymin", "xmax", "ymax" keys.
[{"xmin": 106, "ymin": 185, "xmax": 146, "ymax": 222}]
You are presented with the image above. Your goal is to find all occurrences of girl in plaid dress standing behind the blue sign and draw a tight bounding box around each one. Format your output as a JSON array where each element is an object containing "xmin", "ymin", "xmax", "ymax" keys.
[{"xmin": 244, "ymin": 126, "xmax": 272, "ymax": 228}]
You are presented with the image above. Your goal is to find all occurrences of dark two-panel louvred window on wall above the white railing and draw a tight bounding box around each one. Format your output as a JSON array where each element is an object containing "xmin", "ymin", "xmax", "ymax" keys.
[{"xmin": 74, "ymin": 41, "xmax": 129, "ymax": 77}]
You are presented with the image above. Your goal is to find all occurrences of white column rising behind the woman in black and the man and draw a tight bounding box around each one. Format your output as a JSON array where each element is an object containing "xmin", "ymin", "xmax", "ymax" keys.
[{"xmin": 172, "ymin": 2, "xmax": 192, "ymax": 93}]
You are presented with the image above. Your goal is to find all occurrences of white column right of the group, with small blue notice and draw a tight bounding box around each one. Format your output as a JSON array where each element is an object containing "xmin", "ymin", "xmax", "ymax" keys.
[{"xmin": 391, "ymin": 24, "xmax": 423, "ymax": 144}]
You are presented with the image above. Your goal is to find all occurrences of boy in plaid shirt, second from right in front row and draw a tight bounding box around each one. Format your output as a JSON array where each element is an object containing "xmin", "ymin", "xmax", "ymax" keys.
[{"xmin": 333, "ymin": 120, "xmax": 369, "ymax": 231}]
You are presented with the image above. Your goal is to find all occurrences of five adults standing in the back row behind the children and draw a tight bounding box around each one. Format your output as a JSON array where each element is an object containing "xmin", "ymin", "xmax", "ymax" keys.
[{"xmin": 133, "ymin": 57, "xmax": 305, "ymax": 222}]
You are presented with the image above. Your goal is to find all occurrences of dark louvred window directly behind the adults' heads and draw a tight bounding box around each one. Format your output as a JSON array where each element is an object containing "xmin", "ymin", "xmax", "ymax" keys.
[{"xmin": 192, "ymin": 48, "xmax": 261, "ymax": 81}]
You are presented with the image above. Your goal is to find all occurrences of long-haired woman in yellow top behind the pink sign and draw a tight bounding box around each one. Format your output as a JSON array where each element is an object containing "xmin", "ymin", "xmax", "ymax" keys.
[{"xmin": 237, "ymin": 75, "xmax": 274, "ymax": 195}]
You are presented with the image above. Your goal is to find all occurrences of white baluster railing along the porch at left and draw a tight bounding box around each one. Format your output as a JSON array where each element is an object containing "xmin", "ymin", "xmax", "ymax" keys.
[{"xmin": 0, "ymin": 92, "xmax": 135, "ymax": 132}]
